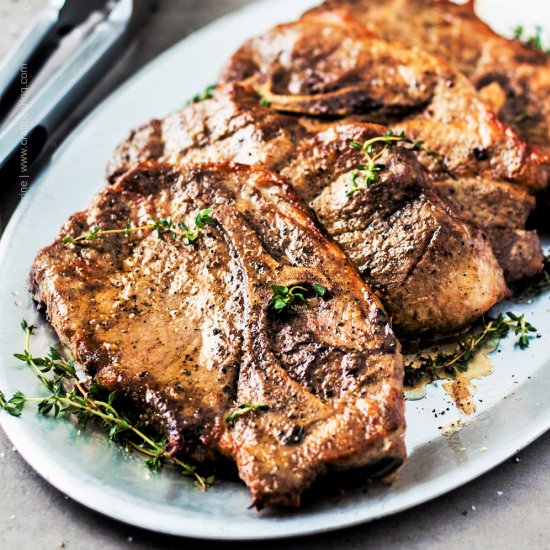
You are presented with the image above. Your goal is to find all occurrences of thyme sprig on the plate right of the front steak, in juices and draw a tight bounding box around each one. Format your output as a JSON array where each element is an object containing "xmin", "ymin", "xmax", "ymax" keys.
[{"xmin": 404, "ymin": 312, "xmax": 537, "ymax": 387}]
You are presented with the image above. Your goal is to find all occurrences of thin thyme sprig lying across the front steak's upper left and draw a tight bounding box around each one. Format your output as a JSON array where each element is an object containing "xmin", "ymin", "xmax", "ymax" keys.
[{"xmin": 63, "ymin": 208, "xmax": 217, "ymax": 245}]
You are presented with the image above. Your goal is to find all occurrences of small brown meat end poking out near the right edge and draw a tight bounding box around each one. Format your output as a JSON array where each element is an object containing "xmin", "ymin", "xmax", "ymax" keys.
[{"xmin": 486, "ymin": 229, "xmax": 544, "ymax": 282}]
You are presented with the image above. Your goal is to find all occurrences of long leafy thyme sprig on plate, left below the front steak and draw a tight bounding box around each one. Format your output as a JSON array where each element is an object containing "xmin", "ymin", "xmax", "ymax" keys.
[{"xmin": 0, "ymin": 320, "xmax": 214, "ymax": 489}]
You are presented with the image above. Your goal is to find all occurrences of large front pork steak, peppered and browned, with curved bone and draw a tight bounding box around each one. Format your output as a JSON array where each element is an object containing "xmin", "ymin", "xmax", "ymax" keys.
[{"xmin": 32, "ymin": 162, "xmax": 405, "ymax": 507}]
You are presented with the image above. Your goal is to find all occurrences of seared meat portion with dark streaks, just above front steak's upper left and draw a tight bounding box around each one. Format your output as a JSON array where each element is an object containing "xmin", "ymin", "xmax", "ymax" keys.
[{"xmin": 107, "ymin": 85, "xmax": 306, "ymax": 182}]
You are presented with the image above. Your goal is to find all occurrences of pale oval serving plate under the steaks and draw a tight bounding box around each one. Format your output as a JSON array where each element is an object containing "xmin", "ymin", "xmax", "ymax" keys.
[{"xmin": 0, "ymin": 0, "xmax": 550, "ymax": 539}]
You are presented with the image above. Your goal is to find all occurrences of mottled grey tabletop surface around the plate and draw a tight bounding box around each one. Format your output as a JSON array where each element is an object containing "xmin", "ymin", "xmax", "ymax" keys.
[{"xmin": 0, "ymin": 0, "xmax": 550, "ymax": 550}]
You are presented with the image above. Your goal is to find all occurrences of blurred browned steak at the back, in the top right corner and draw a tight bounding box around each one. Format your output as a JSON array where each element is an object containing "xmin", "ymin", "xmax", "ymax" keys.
[{"xmin": 306, "ymin": 0, "xmax": 550, "ymax": 160}]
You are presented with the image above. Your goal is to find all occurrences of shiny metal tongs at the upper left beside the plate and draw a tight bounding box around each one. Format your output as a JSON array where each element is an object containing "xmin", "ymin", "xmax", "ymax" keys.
[{"xmin": 0, "ymin": 0, "xmax": 140, "ymax": 175}]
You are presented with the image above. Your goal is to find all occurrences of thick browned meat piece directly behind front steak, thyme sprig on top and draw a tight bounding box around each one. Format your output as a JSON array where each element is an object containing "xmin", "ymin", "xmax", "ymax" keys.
[{"xmin": 281, "ymin": 123, "xmax": 508, "ymax": 334}]
